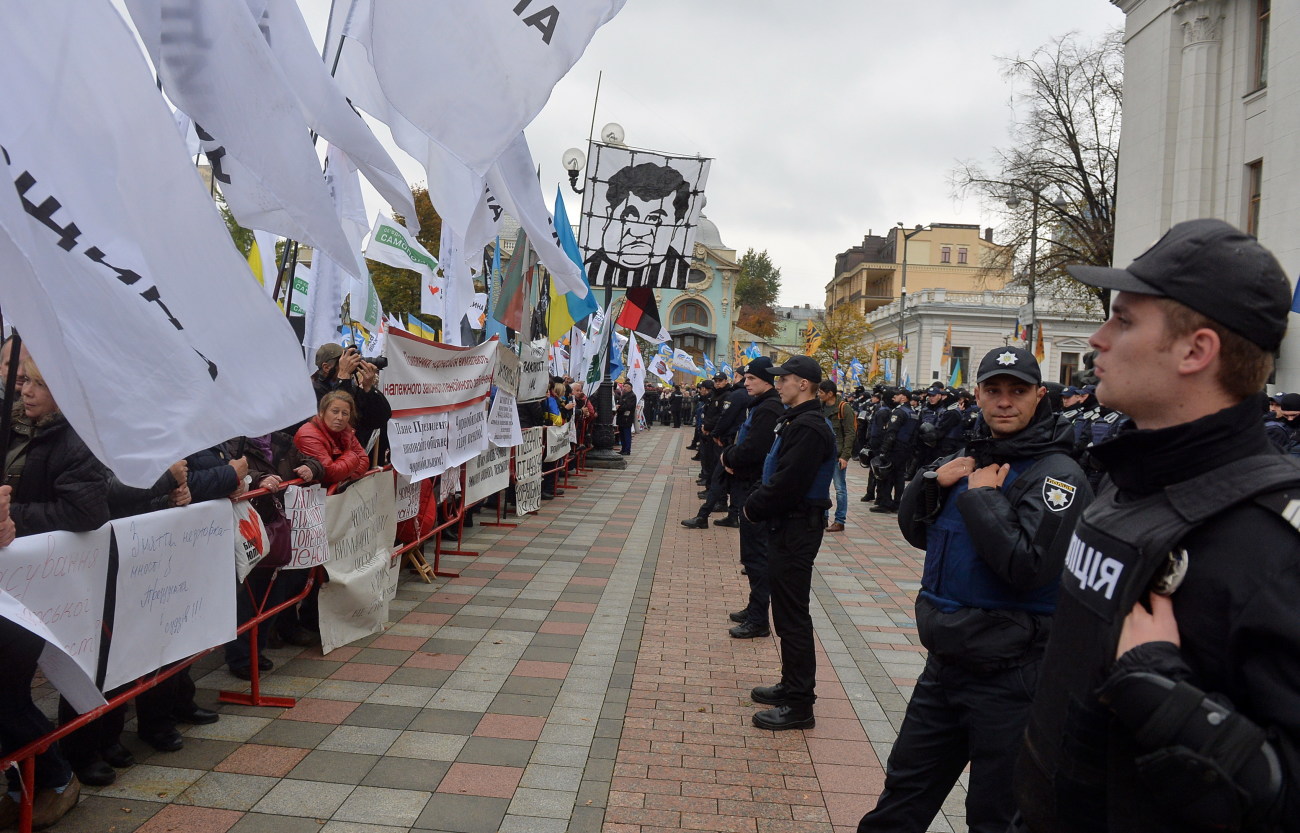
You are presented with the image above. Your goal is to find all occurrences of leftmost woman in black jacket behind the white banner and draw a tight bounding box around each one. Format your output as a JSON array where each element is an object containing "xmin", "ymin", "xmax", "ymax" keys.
[{"xmin": 0, "ymin": 359, "xmax": 108, "ymax": 829}]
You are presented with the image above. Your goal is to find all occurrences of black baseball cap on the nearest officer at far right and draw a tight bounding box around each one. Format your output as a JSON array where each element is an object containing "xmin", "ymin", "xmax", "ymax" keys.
[{"xmin": 1066, "ymin": 220, "xmax": 1291, "ymax": 352}]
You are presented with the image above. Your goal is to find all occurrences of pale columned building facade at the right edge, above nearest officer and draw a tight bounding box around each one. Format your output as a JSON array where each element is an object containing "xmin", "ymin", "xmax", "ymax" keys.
[{"xmin": 1113, "ymin": 0, "xmax": 1300, "ymax": 390}]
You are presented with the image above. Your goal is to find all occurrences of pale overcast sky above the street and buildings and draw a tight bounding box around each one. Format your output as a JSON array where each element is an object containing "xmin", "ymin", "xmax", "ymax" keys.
[{"xmin": 299, "ymin": 0, "xmax": 1123, "ymax": 307}]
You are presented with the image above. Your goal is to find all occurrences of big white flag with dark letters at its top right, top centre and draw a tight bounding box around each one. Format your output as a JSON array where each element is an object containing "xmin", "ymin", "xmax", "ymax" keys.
[{"xmin": 371, "ymin": 0, "xmax": 625, "ymax": 175}]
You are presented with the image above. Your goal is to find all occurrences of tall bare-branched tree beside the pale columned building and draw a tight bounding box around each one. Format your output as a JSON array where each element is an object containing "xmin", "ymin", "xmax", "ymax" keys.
[{"xmin": 953, "ymin": 31, "xmax": 1123, "ymax": 313}]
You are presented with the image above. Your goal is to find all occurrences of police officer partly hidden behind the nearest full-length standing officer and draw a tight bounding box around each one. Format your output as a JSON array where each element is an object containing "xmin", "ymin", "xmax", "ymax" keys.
[{"xmin": 719, "ymin": 356, "xmax": 785, "ymax": 639}]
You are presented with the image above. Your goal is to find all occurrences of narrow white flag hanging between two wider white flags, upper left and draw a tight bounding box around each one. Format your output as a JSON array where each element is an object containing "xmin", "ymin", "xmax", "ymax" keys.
[{"xmin": 250, "ymin": 0, "xmax": 420, "ymax": 233}]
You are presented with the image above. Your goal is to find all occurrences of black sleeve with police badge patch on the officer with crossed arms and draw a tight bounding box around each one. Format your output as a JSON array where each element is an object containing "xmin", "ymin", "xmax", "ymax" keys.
[{"xmin": 957, "ymin": 456, "xmax": 1092, "ymax": 590}]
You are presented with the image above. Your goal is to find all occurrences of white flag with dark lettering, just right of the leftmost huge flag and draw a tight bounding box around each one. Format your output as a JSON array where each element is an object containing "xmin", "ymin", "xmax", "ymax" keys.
[{"xmin": 122, "ymin": 0, "xmax": 361, "ymax": 278}]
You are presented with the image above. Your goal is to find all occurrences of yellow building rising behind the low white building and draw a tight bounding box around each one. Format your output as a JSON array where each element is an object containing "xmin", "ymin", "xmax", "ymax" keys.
[{"xmin": 826, "ymin": 222, "xmax": 1011, "ymax": 314}]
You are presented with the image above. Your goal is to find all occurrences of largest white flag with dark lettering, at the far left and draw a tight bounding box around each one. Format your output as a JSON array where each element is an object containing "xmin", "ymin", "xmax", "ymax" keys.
[{"xmin": 0, "ymin": 0, "xmax": 316, "ymax": 486}]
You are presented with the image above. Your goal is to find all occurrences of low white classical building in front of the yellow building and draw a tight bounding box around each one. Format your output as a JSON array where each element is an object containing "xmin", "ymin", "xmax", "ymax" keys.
[{"xmin": 858, "ymin": 290, "xmax": 1100, "ymax": 387}]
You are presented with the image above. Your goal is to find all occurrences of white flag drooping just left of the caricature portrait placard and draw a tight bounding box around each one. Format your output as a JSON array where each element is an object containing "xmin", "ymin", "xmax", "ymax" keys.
[{"xmin": 488, "ymin": 134, "xmax": 590, "ymax": 298}]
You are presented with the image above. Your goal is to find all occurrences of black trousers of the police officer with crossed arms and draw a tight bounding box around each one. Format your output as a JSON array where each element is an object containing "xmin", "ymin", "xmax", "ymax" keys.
[{"xmin": 858, "ymin": 656, "xmax": 1040, "ymax": 833}]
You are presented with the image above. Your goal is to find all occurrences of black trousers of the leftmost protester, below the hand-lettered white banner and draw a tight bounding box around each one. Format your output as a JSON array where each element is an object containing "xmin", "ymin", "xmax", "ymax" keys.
[{"xmin": 0, "ymin": 619, "xmax": 73, "ymax": 791}]
